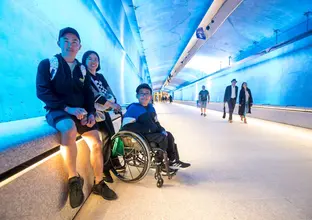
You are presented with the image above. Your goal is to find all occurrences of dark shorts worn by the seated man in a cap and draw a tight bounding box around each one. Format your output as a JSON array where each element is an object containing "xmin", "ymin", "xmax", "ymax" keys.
[{"xmin": 46, "ymin": 110, "xmax": 98, "ymax": 135}]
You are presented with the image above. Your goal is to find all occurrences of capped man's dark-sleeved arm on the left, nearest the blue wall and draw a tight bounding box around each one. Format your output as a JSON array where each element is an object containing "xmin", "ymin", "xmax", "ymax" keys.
[{"xmin": 36, "ymin": 60, "xmax": 66, "ymax": 110}]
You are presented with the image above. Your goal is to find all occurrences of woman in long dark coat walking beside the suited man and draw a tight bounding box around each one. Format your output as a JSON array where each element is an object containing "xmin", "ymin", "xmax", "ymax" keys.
[{"xmin": 238, "ymin": 82, "xmax": 253, "ymax": 124}]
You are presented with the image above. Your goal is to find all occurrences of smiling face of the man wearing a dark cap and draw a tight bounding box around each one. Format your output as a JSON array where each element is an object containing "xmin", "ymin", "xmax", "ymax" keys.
[{"xmin": 58, "ymin": 33, "xmax": 81, "ymax": 57}]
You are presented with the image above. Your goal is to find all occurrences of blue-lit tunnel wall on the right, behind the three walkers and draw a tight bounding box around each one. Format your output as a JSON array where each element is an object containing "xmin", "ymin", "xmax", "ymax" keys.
[{"xmin": 174, "ymin": 36, "xmax": 312, "ymax": 107}]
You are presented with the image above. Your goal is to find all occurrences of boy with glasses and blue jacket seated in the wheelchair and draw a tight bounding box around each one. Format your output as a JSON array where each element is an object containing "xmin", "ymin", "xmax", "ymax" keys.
[{"xmin": 121, "ymin": 83, "xmax": 191, "ymax": 172}]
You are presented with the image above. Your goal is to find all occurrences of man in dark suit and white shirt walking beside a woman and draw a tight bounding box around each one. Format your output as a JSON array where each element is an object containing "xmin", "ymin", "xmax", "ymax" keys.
[{"xmin": 224, "ymin": 79, "xmax": 238, "ymax": 123}]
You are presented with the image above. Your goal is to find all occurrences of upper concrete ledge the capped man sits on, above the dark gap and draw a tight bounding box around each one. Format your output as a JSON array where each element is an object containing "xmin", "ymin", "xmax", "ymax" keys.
[{"xmin": 0, "ymin": 113, "xmax": 119, "ymax": 174}]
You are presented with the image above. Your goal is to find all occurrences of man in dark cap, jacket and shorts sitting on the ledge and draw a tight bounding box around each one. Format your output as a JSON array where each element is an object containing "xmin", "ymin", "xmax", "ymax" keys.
[{"xmin": 36, "ymin": 27, "xmax": 117, "ymax": 208}]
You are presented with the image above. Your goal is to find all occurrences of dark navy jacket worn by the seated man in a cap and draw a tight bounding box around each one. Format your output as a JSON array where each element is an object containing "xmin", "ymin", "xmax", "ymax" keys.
[{"xmin": 36, "ymin": 54, "xmax": 95, "ymax": 114}]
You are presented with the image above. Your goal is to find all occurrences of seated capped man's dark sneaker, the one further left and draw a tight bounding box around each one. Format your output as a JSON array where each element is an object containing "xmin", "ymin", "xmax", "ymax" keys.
[{"xmin": 68, "ymin": 176, "xmax": 84, "ymax": 209}]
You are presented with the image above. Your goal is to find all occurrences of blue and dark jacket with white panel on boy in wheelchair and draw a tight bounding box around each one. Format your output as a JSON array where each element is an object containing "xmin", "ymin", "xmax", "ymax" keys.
[{"xmin": 122, "ymin": 103, "xmax": 165, "ymax": 134}]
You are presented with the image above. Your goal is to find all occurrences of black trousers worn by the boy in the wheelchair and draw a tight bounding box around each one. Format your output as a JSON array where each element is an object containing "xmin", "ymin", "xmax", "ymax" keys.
[{"xmin": 144, "ymin": 131, "xmax": 179, "ymax": 161}]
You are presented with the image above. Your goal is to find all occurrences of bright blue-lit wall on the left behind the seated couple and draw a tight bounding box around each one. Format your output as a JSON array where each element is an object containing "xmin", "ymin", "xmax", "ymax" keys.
[{"xmin": 0, "ymin": 0, "xmax": 147, "ymax": 122}]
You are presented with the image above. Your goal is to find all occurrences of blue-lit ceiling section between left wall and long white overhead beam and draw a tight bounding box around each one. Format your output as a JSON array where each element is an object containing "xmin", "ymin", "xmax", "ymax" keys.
[{"xmin": 127, "ymin": 0, "xmax": 213, "ymax": 90}]
